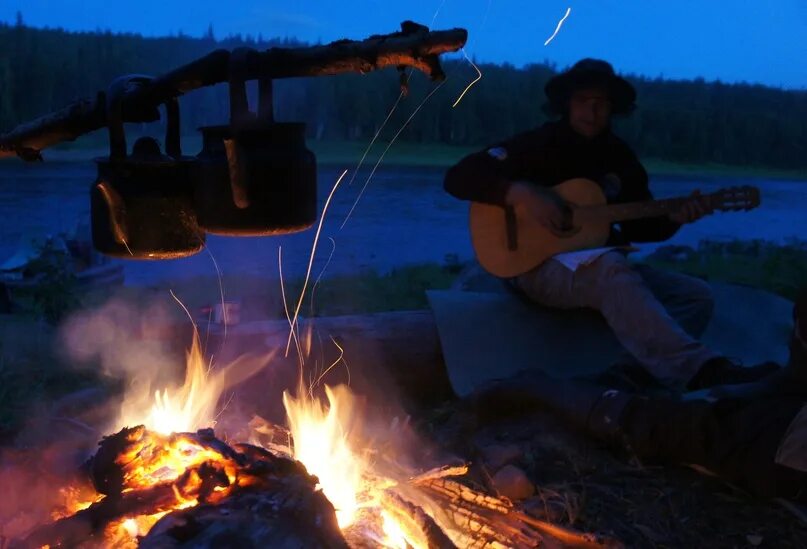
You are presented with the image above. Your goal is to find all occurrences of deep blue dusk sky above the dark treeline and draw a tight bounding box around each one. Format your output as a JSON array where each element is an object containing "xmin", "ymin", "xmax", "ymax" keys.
[{"xmin": 0, "ymin": 0, "xmax": 807, "ymax": 89}]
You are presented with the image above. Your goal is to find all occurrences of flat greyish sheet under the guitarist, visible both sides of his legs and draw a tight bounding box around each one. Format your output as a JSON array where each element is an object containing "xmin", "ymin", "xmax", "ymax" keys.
[{"xmin": 427, "ymin": 283, "xmax": 792, "ymax": 395}]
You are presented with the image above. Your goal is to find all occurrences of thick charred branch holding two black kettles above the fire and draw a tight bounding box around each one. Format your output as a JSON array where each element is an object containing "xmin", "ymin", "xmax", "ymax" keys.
[{"xmin": 0, "ymin": 21, "xmax": 468, "ymax": 161}]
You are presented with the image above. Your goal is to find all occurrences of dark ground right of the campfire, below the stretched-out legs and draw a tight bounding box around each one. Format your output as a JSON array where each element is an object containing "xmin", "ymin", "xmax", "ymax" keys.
[{"xmin": 421, "ymin": 402, "xmax": 807, "ymax": 548}]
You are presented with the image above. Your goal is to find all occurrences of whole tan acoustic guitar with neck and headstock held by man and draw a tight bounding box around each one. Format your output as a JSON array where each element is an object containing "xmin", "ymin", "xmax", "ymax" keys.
[{"xmin": 470, "ymin": 179, "xmax": 760, "ymax": 277}]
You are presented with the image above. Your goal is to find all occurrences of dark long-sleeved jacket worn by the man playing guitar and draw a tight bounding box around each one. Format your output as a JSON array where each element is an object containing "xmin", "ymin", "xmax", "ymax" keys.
[{"xmin": 444, "ymin": 120, "xmax": 680, "ymax": 245}]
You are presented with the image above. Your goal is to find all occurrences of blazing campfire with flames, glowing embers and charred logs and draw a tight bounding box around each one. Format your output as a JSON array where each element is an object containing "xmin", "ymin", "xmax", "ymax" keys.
[{"xmin": 10, "ymin": 324, "xmax": 620, "ymax": 549}]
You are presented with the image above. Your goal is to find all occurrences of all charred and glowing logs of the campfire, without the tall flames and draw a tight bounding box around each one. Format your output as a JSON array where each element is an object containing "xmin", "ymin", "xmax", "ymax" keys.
[{"xmin": 15, "ymin": 421, "xmax": 619, "ymax": 549}]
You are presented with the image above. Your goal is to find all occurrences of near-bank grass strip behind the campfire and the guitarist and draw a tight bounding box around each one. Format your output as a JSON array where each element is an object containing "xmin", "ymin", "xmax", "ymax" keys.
[{"xmin": 0, "ymin": 240, "xmax": 807, "ymax": 440}]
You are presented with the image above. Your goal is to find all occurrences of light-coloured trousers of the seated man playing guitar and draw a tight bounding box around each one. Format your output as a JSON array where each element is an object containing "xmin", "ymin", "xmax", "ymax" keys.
[{"xmin": 516, "ymin": 251, "xmax": 717, "ymax": 388}]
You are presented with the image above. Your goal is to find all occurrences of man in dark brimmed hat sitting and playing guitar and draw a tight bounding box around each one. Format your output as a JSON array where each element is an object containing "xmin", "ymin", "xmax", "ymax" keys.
[{"xmin": 445, "ymin": 59, "xmax": 771, "ymax": 390}]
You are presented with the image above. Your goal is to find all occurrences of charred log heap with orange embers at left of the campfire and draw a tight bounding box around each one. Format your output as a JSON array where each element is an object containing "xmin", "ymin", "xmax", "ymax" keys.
[{"xmin": 12, "ymin": 426, "xmax": 347, "ymax": 547}]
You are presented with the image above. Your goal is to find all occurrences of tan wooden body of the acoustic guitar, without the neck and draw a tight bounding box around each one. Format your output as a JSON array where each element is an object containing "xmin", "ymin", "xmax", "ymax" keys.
[{"xmin": 469, "ymin": 178, "xmax": 611, "ymax": 277}]
